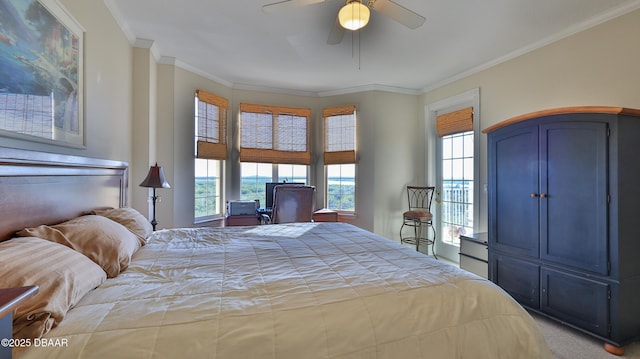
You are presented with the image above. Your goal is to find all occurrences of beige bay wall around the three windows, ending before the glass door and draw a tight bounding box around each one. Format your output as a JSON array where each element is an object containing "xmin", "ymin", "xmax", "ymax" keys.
[{"xmin": 157, "ymin": 73, "xmax": 422, "ymax": 238}]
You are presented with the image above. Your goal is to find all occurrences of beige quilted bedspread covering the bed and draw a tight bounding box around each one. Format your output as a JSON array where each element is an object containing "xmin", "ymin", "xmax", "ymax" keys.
[{"xmin": 20, "ymin": 223, "xmax": 550, "ymax": 359}]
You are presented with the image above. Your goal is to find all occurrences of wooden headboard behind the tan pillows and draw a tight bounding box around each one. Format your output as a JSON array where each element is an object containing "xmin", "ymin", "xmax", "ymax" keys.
[{"xmin": 0, "ymin": 147, "xmax": 128, "ymax": 241}]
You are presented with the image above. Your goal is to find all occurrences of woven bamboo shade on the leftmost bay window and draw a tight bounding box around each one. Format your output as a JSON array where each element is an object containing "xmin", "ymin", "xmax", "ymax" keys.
[{"xmin": 196, "ymin": 90, "xmax": 229, "ymax": 160}]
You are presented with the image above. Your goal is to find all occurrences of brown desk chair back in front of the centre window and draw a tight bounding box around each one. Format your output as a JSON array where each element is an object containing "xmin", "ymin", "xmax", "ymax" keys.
[{"xmin": 270, "ymin": 185, "xmax": 316, "ymax": 223}]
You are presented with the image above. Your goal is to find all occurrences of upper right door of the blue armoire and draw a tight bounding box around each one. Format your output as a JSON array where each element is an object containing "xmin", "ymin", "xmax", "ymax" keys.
[{"xmin": 540, "ymin": 121, "xmax": 608, "ymax": 274}]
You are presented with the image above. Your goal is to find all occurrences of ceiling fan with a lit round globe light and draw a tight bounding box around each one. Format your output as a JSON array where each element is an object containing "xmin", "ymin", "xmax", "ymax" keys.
[{"xmin": 262, "ymin": 0, "xmax": 425, "ymax": 45}]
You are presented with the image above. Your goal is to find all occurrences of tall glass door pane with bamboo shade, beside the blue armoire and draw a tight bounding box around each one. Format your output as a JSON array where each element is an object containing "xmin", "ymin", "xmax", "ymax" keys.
[{"xmin": 436, "ymin": 107, "xmax": 475, "ymax": 246}]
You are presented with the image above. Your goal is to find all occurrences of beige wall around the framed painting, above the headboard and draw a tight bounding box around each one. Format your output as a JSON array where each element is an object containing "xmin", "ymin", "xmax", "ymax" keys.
[{"xmin": 0, "ymin": 0, "xmax": 132, "ymax": 162}]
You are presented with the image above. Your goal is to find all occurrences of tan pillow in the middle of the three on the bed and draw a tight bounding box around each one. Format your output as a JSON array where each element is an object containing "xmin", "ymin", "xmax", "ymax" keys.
[{"xmin": 18, "ymin": 215, "xmax": 140, "ymax": 278}]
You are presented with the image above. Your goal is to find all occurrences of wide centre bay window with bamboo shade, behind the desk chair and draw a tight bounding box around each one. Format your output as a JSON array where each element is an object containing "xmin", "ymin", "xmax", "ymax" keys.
[{"xmin": 240, "ymin": 104, "xmax": 311, "ymax": 204}]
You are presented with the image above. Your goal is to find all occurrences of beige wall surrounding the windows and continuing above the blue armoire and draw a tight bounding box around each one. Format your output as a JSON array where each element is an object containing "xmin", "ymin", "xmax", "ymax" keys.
[{"xmin": 144, "ymin": 11, "xmax": 640, "ymax": 243}]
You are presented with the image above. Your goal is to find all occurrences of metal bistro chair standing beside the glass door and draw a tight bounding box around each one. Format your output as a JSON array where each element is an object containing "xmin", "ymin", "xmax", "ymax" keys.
[{"xmin": 400, "ymin": 186, "xmax": 438, "ymax": 259}]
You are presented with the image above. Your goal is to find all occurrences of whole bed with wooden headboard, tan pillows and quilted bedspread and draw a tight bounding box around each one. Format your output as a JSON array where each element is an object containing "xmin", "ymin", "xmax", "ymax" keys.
[{"xmin": 0, "ymin": 149, "xmax": 551, "ymax": 358}]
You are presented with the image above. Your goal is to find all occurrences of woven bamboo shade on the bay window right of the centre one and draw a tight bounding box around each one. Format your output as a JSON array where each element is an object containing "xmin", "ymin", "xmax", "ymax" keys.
[{"xmin": 322, "ymin": 105, "xmax": 356, "ymax": 165}]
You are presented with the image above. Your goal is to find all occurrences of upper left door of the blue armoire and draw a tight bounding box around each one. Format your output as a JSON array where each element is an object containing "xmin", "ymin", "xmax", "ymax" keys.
[{"xmin": 488, "ymin": 125, "xmax": 539, "ymax": 258}]
